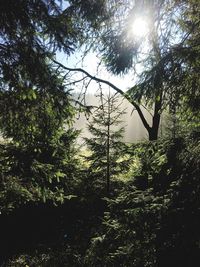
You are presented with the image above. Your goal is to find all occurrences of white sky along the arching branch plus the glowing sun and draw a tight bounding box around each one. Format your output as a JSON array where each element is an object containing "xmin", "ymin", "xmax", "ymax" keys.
[{"xmin": 54, "ymin": 9, "xmax": 148, "ymax": 93}]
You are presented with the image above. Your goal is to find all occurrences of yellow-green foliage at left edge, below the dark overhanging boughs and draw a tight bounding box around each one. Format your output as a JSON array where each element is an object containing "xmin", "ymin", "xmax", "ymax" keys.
[{"xmin": 0, "ymin": 87, "xmax": 75, "ymax": 146}]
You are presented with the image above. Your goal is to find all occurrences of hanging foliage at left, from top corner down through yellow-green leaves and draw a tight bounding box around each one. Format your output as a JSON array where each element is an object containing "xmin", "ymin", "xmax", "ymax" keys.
[{"xmin": 0, "ymin": 0, "xmax": 108, "ymax": 140}]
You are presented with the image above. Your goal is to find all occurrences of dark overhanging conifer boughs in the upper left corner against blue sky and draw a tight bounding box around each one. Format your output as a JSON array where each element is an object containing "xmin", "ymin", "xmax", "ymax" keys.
[{"xmin": 0, "ymin": 0, "xmax": 80, "ymax": 90}]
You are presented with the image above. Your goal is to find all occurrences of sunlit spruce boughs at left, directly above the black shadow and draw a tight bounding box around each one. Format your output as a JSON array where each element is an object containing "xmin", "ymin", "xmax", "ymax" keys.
[{"xmin": 0, "ymin": 129, "xmax": 79, "ymax": 212}]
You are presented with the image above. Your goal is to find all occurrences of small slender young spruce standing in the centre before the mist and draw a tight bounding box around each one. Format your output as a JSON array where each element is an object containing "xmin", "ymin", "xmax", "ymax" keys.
[{"xmin": 84, "ymin": 91, "xmax": 128, "ymax": 194}]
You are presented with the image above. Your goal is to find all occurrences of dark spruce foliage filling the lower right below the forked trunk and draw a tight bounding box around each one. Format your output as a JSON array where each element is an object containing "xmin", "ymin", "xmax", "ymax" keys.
[{"xmin": 85, "ymin": 136, "xmax": 200, "ymax": 267}]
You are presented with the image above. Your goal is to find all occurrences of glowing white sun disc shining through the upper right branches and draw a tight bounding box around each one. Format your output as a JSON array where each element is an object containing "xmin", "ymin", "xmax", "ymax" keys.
[{"xmin": 131, "ymin": 18, "xmax": 148, "ymax": 38}]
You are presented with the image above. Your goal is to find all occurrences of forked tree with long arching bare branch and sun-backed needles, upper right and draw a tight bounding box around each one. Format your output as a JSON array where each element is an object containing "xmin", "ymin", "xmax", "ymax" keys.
[{"xmin": 53, "ymin": 0, "xmax": 199, "ymax": 140}]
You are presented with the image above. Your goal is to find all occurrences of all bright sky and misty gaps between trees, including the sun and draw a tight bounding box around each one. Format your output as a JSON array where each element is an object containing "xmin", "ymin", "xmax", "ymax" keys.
[{"xmin": 53, "ymin": 1, "xmax": 156, "ymax": 142}]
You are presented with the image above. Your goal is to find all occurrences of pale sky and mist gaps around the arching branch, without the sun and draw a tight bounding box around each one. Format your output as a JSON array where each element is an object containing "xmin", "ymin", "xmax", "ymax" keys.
[{"xmin": 57, "ymin": 49, "xmax": 155, "ymax": 144}]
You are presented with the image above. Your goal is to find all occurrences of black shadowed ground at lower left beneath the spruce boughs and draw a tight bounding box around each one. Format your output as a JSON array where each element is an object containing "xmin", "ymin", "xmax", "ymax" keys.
[{"xmin": 0, "ymin": 199, "xmax": 105, "ymax": 266}]
